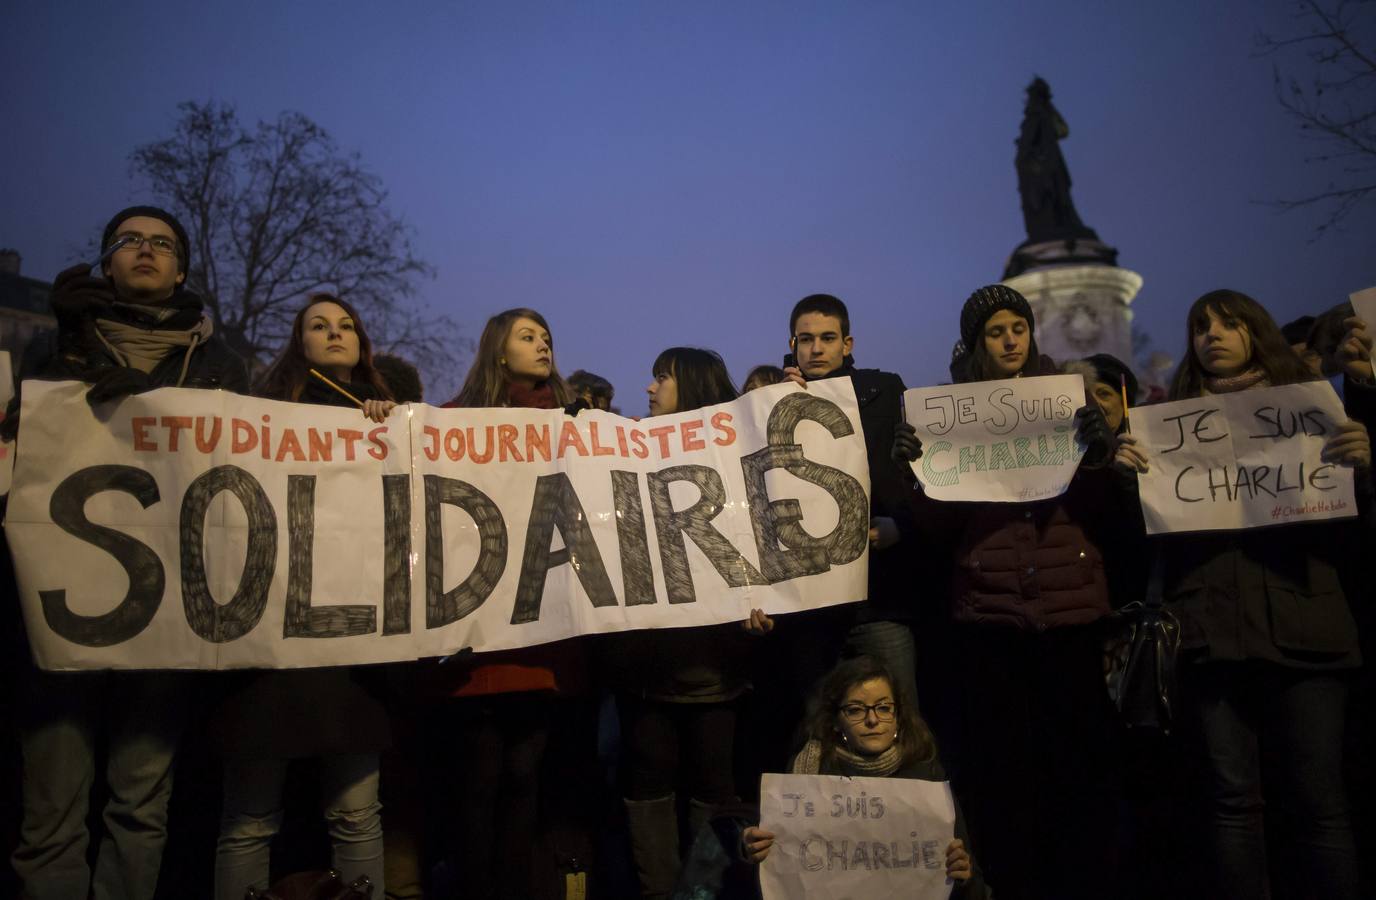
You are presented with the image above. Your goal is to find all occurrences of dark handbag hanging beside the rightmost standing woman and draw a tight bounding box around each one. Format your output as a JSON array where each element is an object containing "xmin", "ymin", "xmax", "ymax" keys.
[{"xmin": 1108, "ymin": 560, "xmax": 1181, "ymax": 733}]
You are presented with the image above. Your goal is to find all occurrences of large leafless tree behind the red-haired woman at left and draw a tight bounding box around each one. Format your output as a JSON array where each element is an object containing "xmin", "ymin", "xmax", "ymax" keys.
[{"xmin": 129, "ymin": 102, "xmax": 469, "ymax": 374}]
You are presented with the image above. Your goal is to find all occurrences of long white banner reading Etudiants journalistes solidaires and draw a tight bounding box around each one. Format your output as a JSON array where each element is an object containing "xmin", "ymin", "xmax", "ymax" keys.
[{"xmin": 6, "ymin": 378, "xmax": 870, "ymax": 669}]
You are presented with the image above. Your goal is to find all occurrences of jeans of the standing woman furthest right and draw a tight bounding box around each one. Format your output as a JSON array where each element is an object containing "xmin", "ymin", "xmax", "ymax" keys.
[{"xmin": 1185, "ymin": 662, "xmax": 1358, "ymax": 900}]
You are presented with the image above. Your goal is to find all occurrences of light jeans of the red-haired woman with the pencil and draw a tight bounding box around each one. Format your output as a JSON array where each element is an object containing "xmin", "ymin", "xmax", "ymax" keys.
[{"xmin": 215, "ymin": 753, "xmax": 385, "ymax": 900}]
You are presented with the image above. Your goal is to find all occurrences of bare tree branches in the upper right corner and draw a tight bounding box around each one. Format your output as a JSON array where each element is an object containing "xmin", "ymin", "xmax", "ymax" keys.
[{"xmin": 1256, "ymin": 0, "xmax": 1376, "ymax": 235}]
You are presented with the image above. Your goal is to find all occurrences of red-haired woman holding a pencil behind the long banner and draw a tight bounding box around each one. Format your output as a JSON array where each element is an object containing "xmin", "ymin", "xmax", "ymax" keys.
[{"xmin": 212, "ymin": 294, "xmax": 395, "ymax": 900}]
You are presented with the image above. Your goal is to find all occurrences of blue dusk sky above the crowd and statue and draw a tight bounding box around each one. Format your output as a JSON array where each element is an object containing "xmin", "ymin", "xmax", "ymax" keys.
[{"xmin": 0, "ymin": 0, "xmax": 1376, "ymax": 414}]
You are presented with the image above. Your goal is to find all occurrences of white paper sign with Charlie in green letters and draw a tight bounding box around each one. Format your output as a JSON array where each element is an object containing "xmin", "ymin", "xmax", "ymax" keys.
[{"xmin": 903, "ymin": 376, "xmax": 1084, "ymax": 502}]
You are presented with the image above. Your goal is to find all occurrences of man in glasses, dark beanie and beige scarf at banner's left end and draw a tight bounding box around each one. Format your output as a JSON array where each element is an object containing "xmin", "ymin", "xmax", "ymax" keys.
[{"xmin": 7, "ymin": 206, "xmax": 248, "ymax": 900}]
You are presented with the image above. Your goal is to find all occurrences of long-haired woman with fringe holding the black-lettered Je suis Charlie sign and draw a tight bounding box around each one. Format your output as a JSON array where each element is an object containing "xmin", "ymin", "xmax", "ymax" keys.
[{"xmin": 1116, "ymin": 290, "xmax": 1370, "ymax": 900}]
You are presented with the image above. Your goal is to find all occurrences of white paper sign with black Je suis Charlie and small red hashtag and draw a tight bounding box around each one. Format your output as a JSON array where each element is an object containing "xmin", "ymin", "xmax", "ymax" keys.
[{"xmin": 1131, "ymin": 381, "xmax": 1357, "ymax": 534}]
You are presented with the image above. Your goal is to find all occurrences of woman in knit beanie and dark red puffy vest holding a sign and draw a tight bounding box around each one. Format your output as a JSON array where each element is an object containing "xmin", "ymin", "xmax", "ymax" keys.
[{"xmin": 893, "ymin": 285, "xmax": 1124, "ymax": 899}]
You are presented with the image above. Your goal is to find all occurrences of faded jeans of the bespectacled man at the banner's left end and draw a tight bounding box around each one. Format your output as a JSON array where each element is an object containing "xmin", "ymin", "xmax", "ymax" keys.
[{"xmin": 11, "ymin": 670, "xmax": 193, "ymax": 900}]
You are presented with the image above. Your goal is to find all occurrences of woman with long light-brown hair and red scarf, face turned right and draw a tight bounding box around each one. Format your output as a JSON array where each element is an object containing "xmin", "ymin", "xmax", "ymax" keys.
[{"xmin": 427, "ymin": 308, "xmax": 588, "ymax": 899}]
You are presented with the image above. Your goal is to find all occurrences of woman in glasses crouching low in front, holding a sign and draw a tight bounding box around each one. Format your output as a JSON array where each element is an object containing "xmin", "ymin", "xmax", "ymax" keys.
[{"xmin": 740, "ymin": 656, "xmax": 1002, "ymax": 900}]
